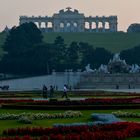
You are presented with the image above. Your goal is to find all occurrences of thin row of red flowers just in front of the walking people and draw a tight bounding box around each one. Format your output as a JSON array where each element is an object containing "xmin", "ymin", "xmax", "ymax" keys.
[{"xmin": 0, "ymin": 97, "xmax": 140, "ymax": 105}]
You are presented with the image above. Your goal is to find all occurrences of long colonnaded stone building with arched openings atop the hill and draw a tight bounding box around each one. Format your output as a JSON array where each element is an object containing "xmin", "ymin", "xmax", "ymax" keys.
[{"xmin": 19, "ymin": 7, "xmax": 118, "ymax": 32}]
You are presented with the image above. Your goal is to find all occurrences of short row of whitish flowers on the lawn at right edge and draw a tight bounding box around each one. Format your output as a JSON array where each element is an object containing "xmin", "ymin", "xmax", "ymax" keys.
[{"xmin": 112, "ymin": 110, "xmax": 140, "ymax": 118}]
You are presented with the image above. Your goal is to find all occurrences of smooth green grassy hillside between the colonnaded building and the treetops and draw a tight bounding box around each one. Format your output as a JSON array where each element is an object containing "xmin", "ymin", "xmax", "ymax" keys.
[{"xmin": 44, "ymin": 33, "xmax": 140, "ymax": 52}]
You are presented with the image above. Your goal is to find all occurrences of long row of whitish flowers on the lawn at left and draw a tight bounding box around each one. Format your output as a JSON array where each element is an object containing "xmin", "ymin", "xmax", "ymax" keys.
[{"xmin": 0, "ymin": 111, "xmax": 82, "ymax": 120}]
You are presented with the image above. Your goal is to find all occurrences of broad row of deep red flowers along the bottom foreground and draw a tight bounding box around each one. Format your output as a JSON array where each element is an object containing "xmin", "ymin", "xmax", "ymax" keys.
[{"xmin": 0, "ymin": 122, "xmax": 140, "ymax": 140}]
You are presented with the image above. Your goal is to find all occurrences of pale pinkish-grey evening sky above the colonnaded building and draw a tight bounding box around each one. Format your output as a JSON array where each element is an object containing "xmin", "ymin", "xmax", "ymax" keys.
[{"xmin": 0, "ymin": 0, "xmax": 140, "ymax": 31}]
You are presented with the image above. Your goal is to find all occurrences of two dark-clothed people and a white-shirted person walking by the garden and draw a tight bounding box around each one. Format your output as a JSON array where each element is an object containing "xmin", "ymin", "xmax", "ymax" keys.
[{"xmin": 43, "ymin": 85, "xmax": 68, "ymax": 99}]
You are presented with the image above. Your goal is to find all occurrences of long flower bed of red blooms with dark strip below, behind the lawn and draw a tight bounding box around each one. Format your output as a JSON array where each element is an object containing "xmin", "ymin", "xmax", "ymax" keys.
[{"xmin": 1, "ymin": 97, "xmax": 140, "ymax": 110}]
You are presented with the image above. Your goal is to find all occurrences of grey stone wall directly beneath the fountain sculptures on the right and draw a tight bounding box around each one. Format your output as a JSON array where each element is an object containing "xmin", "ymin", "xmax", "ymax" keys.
[{"xmin": 77, "ymin": 74, "xmax": 140, "ymax": 89}]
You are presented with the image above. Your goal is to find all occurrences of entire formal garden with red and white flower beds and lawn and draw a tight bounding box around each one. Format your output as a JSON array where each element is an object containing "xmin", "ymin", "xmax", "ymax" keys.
[{"xmin": 0, "ymin": 91, "xmax": 140, "ymax": 140}]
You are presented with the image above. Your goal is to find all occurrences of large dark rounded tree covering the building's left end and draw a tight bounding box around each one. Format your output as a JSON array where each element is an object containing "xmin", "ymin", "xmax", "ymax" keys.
[{"xmin": 1, "ymin": 23, "xmax": 42, "ymax": 74}]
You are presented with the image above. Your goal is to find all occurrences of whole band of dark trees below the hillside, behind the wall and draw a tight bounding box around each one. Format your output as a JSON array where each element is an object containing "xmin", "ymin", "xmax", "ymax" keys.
[{"xmin": 0, "ymin": 23, "xmax": 140, "ymax": 75}]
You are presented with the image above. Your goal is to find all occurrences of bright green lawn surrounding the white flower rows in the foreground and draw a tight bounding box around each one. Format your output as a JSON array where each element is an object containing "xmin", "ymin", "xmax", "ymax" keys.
[{"xmin": 0, "ymin": 109, "xmax": 140, "ymax": 132}]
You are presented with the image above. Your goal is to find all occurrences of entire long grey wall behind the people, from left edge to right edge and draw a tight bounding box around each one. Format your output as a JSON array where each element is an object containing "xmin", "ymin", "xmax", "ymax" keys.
[{"xmin": 0, "ymin": 70, "xmax": 140, "ymax": 91}]
